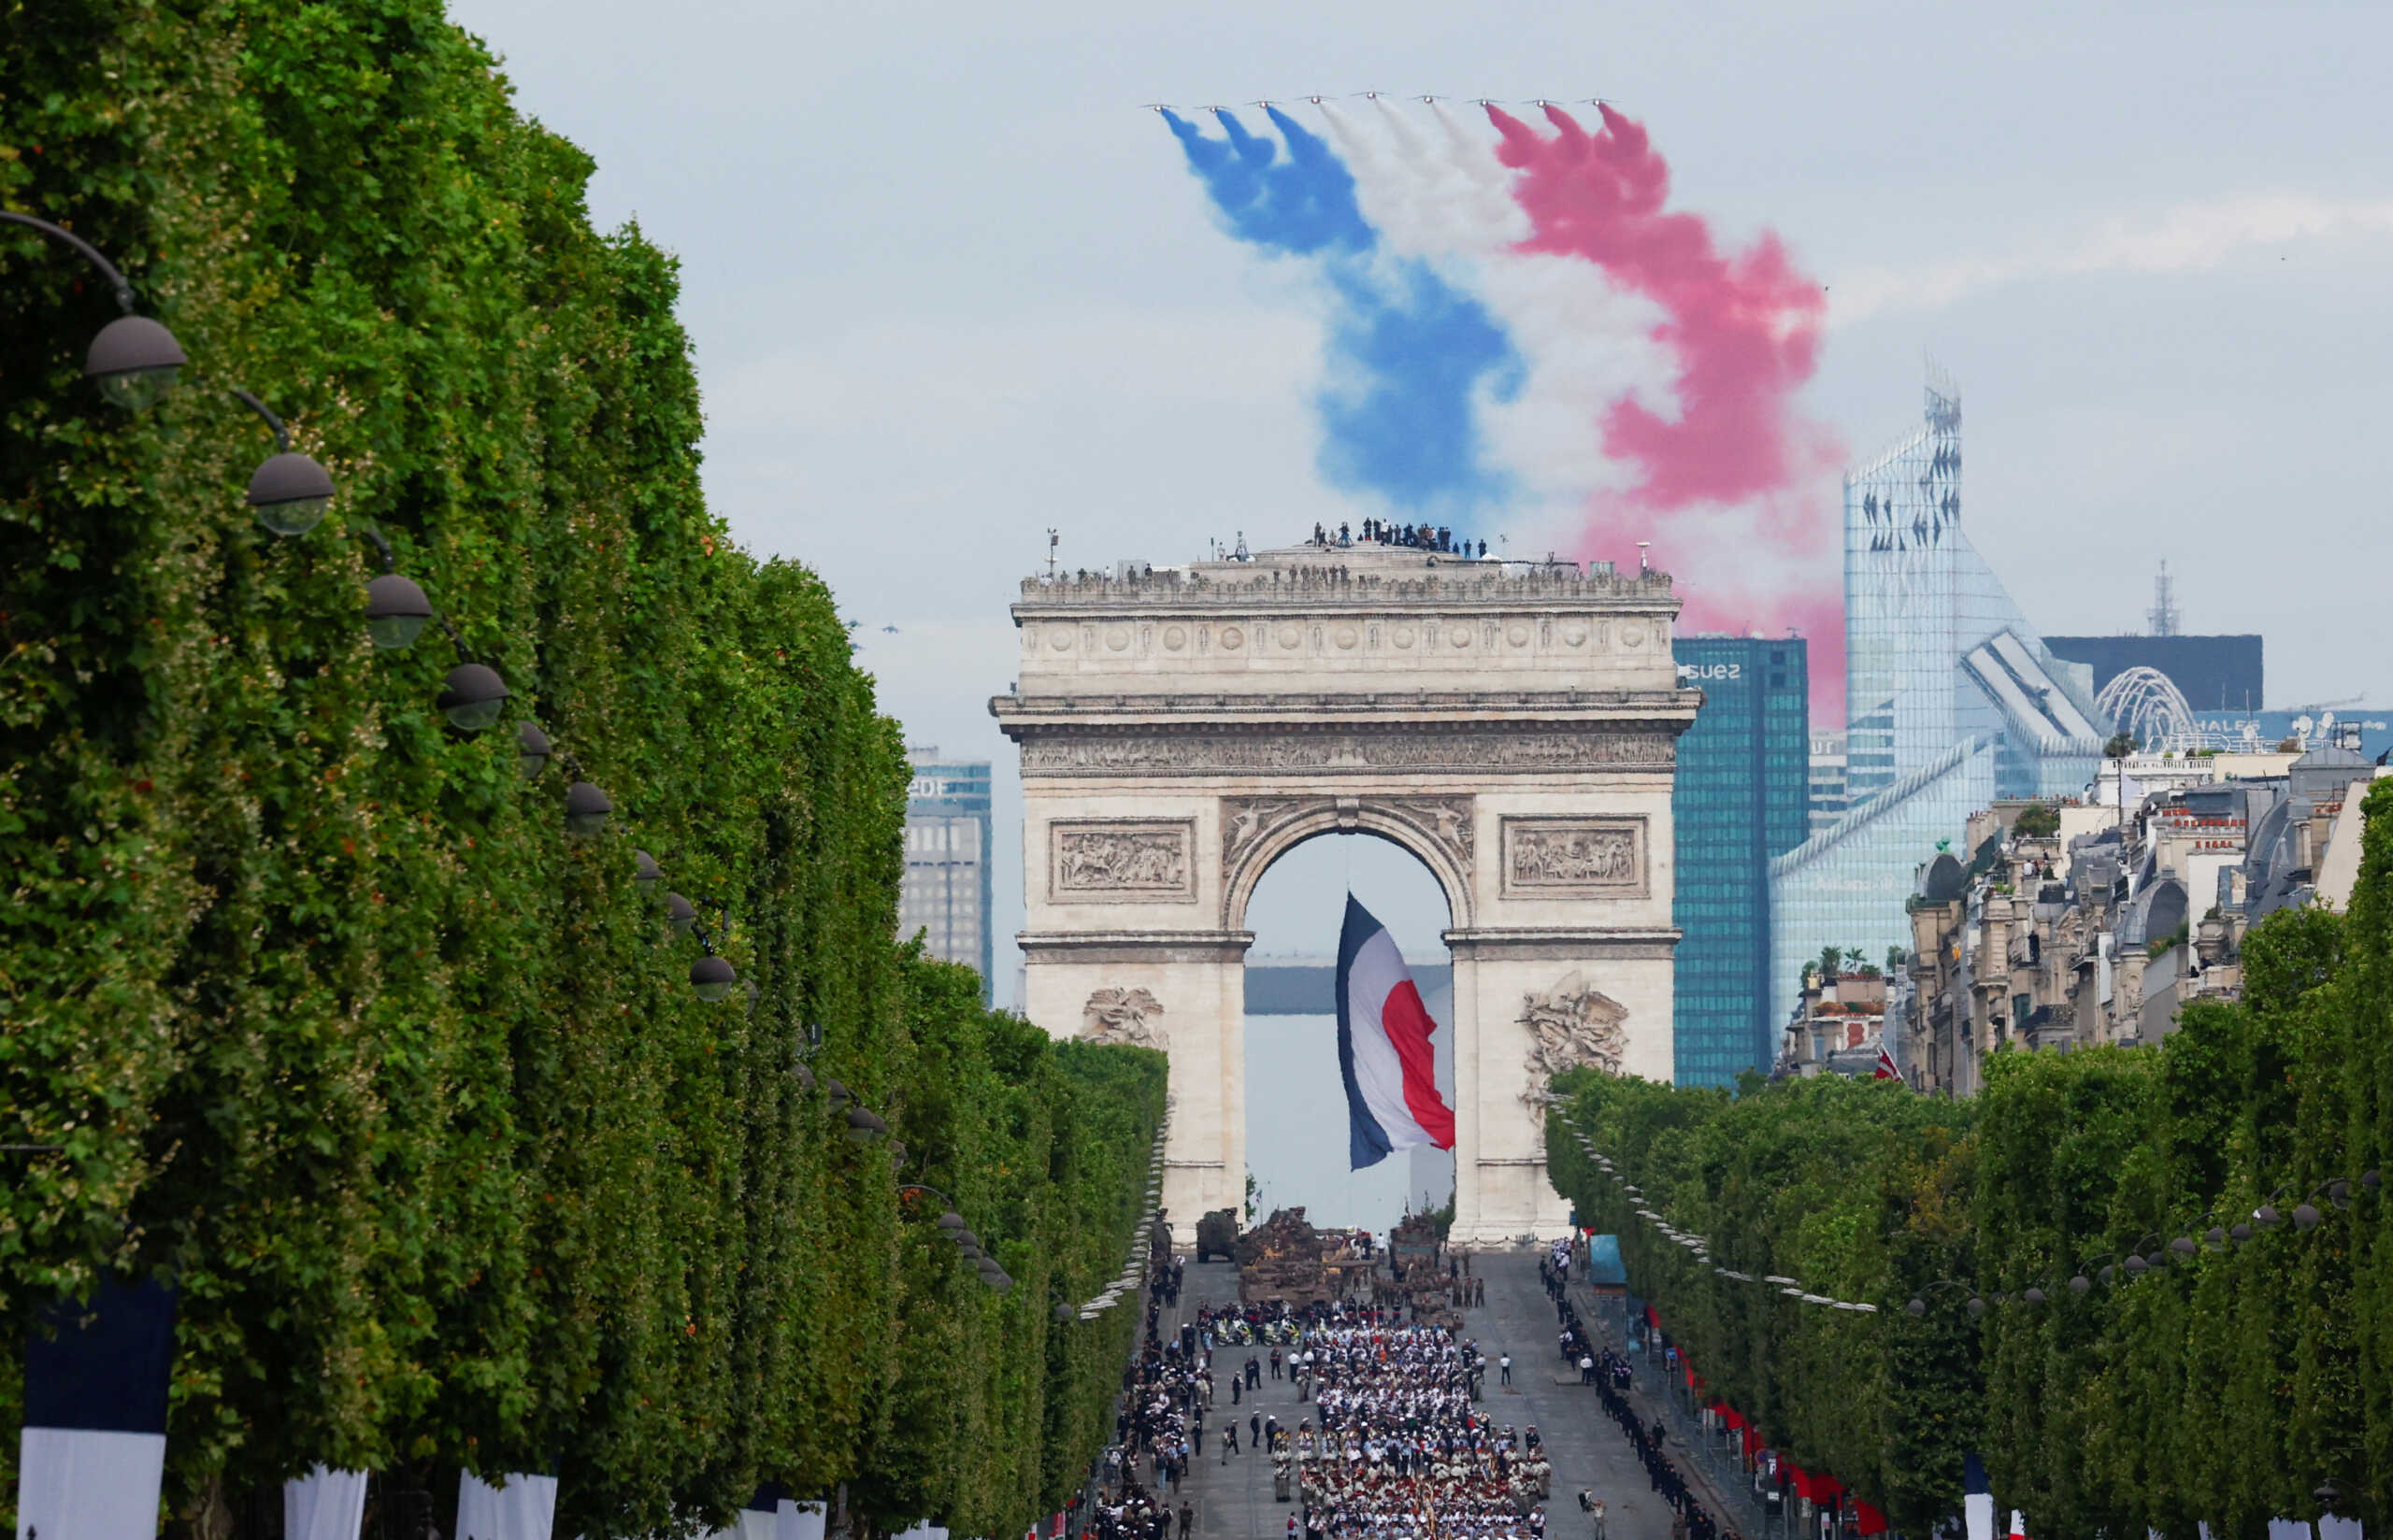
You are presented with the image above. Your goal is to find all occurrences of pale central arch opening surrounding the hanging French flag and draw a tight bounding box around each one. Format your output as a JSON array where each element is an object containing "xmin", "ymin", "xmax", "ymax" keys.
[{"xmin": 1235, "ymin": 827, "xmax": 1454, "ymax": 1232}]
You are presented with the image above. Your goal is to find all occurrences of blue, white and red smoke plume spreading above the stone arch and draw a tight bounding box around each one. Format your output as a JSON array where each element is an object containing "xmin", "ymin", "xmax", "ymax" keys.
[{"xmin": 1166, "ymin": 98, "xmax": 1845, "ymax": 722}]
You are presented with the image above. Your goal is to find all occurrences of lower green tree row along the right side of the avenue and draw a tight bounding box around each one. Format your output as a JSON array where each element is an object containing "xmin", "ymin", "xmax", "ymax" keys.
[{"xmin": 1551, "ymin": 782, "xmax": 2393, "ymax": 1537}]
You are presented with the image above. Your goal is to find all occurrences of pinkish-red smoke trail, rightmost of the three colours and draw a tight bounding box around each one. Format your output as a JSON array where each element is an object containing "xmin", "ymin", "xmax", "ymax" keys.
[{"xmin": 1486, "ymin": 107, "xmax": 1845, "ymax": 724}]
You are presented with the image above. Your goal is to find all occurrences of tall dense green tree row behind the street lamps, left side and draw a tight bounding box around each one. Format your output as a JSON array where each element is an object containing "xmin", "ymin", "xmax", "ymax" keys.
[{"xmin": 0, "ymin": 0, "xmax": 1163, "ymax": 1537}]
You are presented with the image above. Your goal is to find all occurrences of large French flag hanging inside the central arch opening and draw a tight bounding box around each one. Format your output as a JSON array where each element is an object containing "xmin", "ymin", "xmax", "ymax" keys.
[{"xmin": 1338, "ymin": 894, "xmax": 1454, "ymax": 1172}]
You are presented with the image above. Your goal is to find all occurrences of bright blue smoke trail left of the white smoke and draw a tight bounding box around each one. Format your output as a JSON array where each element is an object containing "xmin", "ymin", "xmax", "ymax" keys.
[{"xmin": 1163, "ymin": 107, "xmax": 1522, "ymax": 529}]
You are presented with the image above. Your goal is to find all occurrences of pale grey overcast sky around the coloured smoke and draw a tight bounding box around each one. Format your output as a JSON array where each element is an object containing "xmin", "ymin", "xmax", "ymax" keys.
[{"xmin": 454, "ymin": 0, "xmax": 2393, "ymax": 1000}]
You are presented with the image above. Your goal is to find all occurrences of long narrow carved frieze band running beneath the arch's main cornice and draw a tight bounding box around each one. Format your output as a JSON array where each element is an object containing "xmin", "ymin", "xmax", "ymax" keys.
[{"xmin": 1022, "ymin": 732, "xmax": 1678, "ymax": 775}]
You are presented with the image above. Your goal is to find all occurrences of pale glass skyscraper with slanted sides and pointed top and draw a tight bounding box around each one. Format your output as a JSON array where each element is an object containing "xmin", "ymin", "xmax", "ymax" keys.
[{"xmin": 1770, "ymin": 378, "xmax": 2108, "ymax": 1033}]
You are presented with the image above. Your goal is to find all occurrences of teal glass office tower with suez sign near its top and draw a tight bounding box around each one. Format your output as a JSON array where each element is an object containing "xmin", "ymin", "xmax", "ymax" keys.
[{"xmin": 1670, "ymin": 636, "xmax": 1812, "ymax": 1086}]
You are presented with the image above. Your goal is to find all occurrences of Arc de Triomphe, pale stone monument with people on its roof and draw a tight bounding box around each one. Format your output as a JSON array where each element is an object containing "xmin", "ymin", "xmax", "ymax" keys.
[{"xmin": 991, "ymin": 545, "xmax": 1701, "ymax": 1244}]
